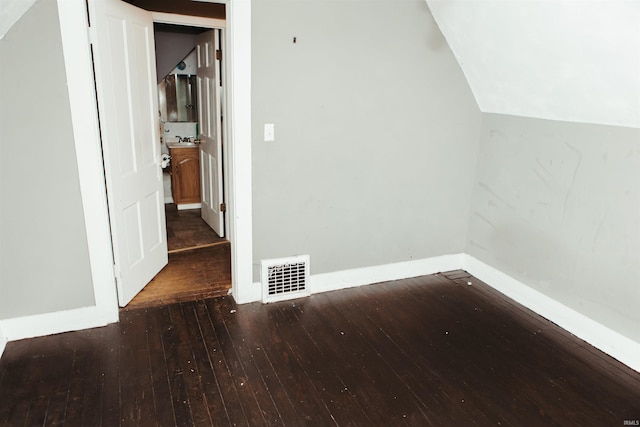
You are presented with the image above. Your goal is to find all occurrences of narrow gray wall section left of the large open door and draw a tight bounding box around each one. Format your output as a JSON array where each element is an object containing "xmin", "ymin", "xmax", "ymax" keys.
[{"xmin": 0, "ymin": 0, "xmax": 95, "ymax": 319}]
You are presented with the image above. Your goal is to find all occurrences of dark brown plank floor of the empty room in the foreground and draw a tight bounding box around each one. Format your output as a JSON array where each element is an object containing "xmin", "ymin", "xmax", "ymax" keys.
[{"xmin": 0, "ymin": 271, "xmax": 640, "ymax": 426}]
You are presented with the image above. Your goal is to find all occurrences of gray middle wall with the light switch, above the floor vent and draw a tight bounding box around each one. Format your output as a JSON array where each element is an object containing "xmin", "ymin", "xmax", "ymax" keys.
[{"xmin": 252, "ymin": 0, "xmax": 481, "ymax": 280}]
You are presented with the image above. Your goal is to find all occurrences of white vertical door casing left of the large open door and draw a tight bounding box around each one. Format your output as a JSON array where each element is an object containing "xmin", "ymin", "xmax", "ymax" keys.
[{"xmin": 57, "ymin": 0, "xmax": 118, "ymax": 324}]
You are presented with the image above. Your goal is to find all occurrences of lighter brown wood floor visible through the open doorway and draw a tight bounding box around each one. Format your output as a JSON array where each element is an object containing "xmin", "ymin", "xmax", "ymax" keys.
[{"xmin": 126, "ymin": 204, "xmax": 231, "ymax": 310}]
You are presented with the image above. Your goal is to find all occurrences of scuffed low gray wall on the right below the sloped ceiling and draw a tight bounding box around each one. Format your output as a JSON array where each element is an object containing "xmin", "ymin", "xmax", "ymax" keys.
[{"xmin": 467, "ymin": 114, "xmax": 640, "ymax": 342}]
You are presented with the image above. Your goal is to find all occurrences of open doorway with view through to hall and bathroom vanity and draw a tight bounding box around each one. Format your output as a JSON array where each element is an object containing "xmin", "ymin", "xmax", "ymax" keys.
[{"xmin": 126, "ymin": 23, "xmax": 232, "ymax": 309}]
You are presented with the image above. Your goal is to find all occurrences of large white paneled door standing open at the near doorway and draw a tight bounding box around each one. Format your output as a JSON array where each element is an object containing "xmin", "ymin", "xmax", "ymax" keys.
[{"xmin": 89, "ymin": 0, "xmax": 167, "ymax": 306}]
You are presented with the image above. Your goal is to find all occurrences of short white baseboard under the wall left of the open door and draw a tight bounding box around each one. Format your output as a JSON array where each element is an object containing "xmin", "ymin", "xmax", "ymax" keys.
[{"xmin": 1, "ymin": 306, "xmax": 113, "ymax": 341}]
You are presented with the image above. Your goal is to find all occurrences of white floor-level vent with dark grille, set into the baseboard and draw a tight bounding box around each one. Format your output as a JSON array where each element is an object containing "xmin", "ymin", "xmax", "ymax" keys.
[{"xmin": 261, "ymin": 255, "xmax": 310, "ymax": 302}]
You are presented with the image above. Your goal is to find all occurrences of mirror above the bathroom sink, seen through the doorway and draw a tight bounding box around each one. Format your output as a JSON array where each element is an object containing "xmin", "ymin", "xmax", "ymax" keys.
[{"xmin": 158, "ymin": 74, "xmax": 198, "ymax": 122}]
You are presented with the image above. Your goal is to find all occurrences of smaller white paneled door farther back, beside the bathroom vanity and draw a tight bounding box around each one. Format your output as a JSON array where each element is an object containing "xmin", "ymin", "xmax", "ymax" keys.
[{"xmin": 196, "ymin": 30, "xmax": 224, "ymax": 237}]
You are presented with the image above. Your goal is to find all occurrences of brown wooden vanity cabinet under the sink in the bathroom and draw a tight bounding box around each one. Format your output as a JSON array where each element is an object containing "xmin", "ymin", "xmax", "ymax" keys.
[{"xmin": 169, "ymin": 147, "xmax": 200, "ymax": 205}]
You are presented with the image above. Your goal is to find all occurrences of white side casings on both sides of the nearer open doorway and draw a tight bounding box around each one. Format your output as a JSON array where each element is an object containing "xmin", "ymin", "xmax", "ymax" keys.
[{"xmin": 58, "ymin": 0, "xmax": 255, "ymax": 327}]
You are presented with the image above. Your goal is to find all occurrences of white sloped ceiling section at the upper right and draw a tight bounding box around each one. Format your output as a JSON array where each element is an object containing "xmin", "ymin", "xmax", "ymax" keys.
[{"xmin": 426, "ymin": 0, "xmax": 640, "ymax": 128}]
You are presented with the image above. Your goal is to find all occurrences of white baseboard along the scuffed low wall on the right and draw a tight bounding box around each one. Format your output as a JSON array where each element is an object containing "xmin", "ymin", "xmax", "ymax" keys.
[{"xmin": 462, "ymin": 255, "xmax": 640, "ymax": 372}]
